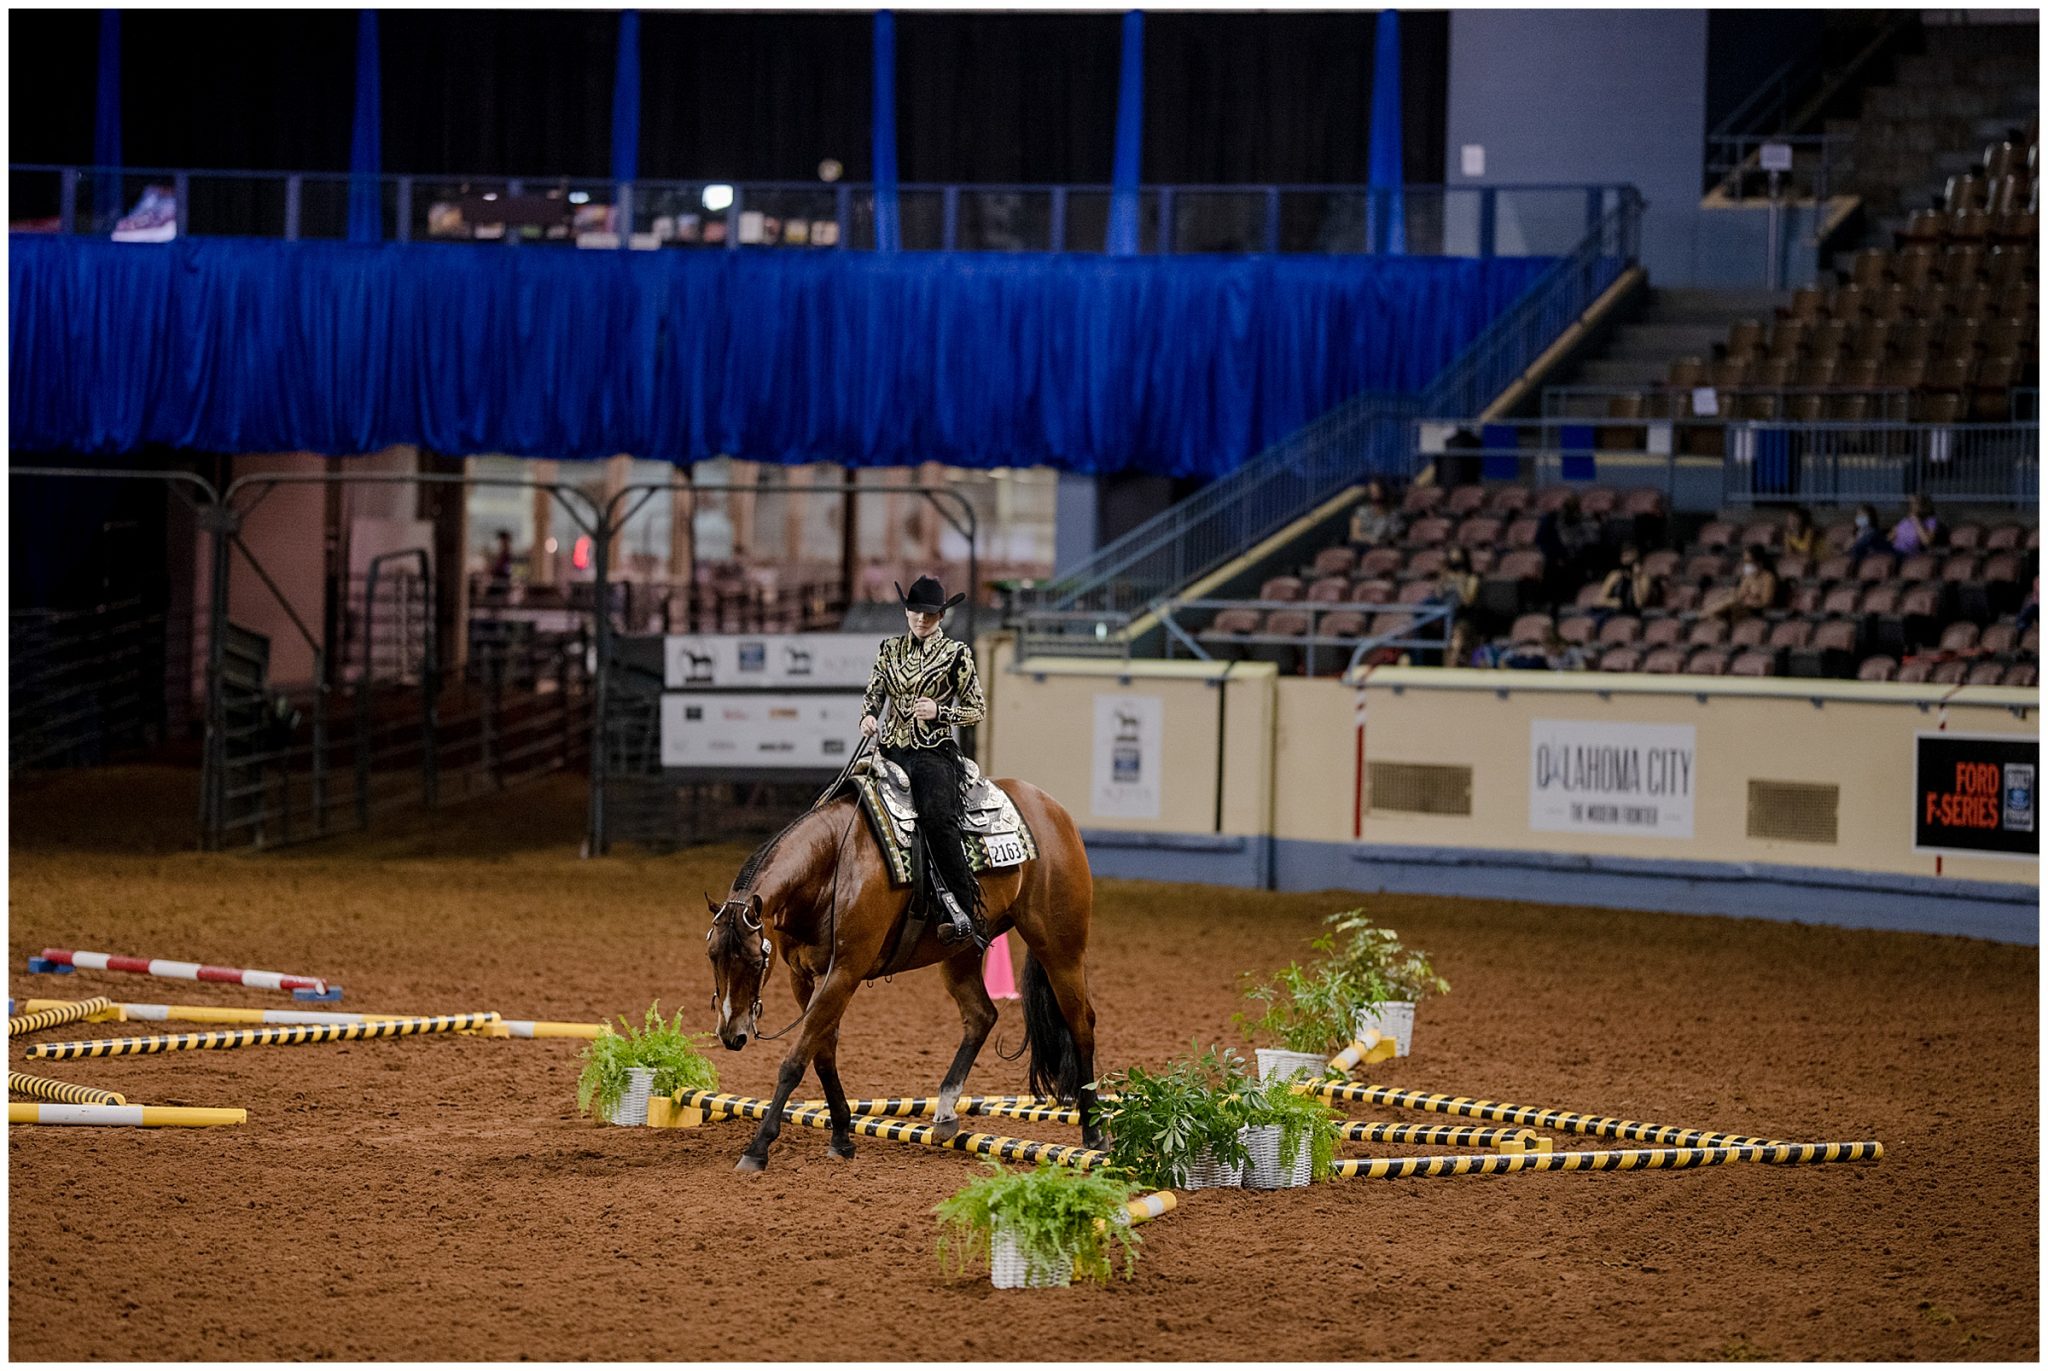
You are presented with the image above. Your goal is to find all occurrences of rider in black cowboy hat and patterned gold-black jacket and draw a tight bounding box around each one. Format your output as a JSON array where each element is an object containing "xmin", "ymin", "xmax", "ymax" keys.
[{"xmin": 860, "ymin": 576, "xmax": 987, "ymax": 947}]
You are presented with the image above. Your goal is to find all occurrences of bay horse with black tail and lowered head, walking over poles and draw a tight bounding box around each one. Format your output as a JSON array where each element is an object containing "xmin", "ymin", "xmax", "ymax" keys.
[{"xmin": 705, "ymin": 779, "xmax": 1102, "ymax": 1172}]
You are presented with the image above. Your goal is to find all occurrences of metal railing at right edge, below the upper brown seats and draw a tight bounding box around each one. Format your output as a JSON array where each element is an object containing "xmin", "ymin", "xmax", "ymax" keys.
[{"xmin": 1722, "ymin": 422, "xmax": 2042, "ymax": 508}]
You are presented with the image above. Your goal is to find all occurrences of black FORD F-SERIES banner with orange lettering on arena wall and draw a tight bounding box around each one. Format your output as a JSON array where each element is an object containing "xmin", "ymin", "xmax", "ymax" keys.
[{"xmin": 1913, "ymin": 734, "xmax": 2042, "ymax": 857}]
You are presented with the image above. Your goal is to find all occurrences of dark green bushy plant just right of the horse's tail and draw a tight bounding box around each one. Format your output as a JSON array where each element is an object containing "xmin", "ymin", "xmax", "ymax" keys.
[{"xmin": 1098, "ymin": 1043, "xmax": 1251, "ymax": 1189}]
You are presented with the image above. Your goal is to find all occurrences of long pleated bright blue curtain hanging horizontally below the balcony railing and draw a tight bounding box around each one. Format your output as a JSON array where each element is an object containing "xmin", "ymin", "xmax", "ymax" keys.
[{"xmin": 8, "ymin": 234, "xmax": 1550, "ymax": 475}]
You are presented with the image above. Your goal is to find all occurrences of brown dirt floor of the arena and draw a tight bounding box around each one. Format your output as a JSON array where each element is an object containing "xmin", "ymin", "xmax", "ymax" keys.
[{"xmin": 8, "ymin": 771, "xmax": 2040, "ymax": 1361}]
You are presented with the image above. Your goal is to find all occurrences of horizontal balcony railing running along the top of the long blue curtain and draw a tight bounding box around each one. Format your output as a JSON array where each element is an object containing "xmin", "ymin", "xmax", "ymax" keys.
[{"xmin": 8, "ymin": 162, "xmax": 1622, "ymax": 256}]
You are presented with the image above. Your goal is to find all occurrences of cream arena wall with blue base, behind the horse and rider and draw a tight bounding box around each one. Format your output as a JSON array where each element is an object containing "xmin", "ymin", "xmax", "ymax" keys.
[{"xmin": 981, "ymin": 635, "xmax": 2040, "ymax": 943}]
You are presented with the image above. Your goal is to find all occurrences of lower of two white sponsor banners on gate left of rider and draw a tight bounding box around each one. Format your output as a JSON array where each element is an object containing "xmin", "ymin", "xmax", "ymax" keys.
[{"xmin": 662, "ymin": 691, "xmax": 860, "ymax": 771}]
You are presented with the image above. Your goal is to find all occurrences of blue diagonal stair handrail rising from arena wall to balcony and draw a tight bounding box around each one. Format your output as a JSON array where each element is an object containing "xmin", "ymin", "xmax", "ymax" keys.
[{"xmin": 1024, "ymin": 186, "xmax": 1642, "ymax": 619}]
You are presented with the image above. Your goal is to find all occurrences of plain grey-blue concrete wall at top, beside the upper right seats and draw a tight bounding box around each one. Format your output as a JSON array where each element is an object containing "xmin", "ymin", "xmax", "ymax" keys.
[{"xmin": 1444, "ymin": 10, "xmax": 1706, "ymax": 285}]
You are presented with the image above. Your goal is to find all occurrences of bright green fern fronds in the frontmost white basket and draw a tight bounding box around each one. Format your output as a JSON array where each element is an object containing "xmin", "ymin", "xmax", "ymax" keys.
[{"xmin": 934, "ymin": 1160, "xmax": 1139, "ymax": 1283}]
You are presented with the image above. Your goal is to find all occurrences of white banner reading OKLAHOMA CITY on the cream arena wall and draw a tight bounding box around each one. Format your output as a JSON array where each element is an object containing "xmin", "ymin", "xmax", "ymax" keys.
[{"xmin": 1530, "ymin": 719, "xmax": 1700, "ymax": 838}]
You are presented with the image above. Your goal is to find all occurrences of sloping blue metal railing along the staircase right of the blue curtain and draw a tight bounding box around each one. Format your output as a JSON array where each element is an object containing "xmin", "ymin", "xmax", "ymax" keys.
[{"xmin": 1020, "ymin": 186, "xmax": 1642, "ymax": 656}]
